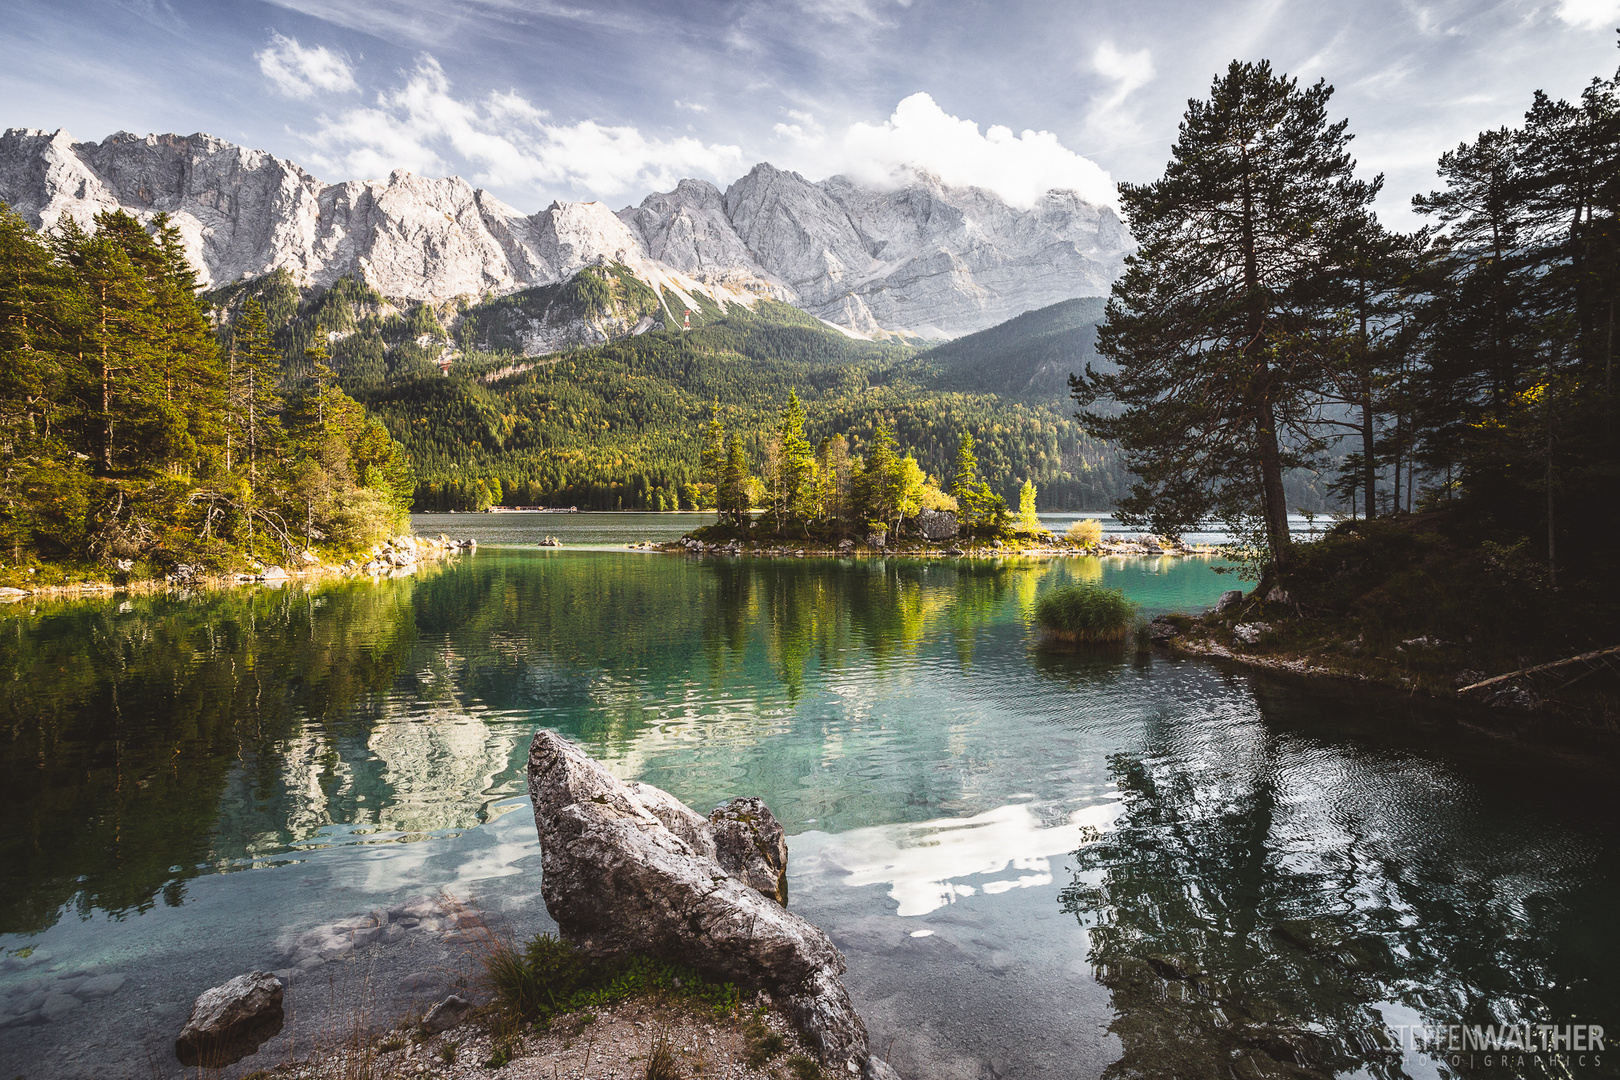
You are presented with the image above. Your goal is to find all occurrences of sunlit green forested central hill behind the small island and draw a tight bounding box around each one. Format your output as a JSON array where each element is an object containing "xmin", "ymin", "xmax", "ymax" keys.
[{"xmin": 356, "ymin": 303, "xmax": 1121, "ymax": 510}]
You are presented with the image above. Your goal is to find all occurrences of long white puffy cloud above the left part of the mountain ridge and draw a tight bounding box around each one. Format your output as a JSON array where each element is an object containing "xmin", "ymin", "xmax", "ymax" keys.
[{"xmin": 311, "ymin": 55, "xmax": 742, "ymax": 198}]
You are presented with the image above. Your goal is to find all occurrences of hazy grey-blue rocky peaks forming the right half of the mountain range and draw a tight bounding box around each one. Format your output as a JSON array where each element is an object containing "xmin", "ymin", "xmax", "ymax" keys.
[{"xmin": 619, "ymin": 164, "xmax": 1131, "ymax": 337}]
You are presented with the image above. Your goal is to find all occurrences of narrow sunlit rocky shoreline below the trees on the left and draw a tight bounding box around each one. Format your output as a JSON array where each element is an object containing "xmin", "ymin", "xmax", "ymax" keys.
[{"xmin": 0, "ymin": 533, "xmax": 478, "ymax": 610}]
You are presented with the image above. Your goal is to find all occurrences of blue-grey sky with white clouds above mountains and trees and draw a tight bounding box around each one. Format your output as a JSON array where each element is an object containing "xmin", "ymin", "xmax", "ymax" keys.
[{"xmin": 0, "ymin": 0, "xmax": 1620, "ymax": 228}]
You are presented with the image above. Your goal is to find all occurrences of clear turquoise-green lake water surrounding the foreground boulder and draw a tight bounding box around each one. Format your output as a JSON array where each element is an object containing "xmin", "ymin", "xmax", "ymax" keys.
[{"xmin": 0, "ymin": 550, "xmax": 1620, "ymax": 1078}]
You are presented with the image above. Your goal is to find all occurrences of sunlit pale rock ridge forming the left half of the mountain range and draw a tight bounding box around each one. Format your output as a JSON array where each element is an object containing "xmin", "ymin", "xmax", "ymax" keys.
[{"xmin": 0, "ymin": 128, "xmax": 747, "ymax": 314}]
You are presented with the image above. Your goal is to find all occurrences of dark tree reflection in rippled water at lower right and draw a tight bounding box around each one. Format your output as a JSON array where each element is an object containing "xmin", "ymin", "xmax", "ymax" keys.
[{"xmin": 1059, "ymin": 688, "xmax": 1620, "ymax": 1080}]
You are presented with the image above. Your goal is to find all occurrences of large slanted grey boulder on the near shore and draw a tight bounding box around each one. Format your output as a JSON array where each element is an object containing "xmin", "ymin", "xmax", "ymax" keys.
[{"xmin": 528, "ymin": 730, "xmax": 896, "ymax": 1080}]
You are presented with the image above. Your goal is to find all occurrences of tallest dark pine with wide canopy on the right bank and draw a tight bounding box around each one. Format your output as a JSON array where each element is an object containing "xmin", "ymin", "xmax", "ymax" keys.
[{"xmin": 1071, "ymin": 60, "xmax": 1379, "ymax": 570}]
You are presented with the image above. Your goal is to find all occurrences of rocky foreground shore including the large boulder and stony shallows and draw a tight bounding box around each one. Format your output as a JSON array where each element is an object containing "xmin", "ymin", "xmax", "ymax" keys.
[{"xmin": 63, "ymin": 729, "xmax": 899, "ymax": 1080}]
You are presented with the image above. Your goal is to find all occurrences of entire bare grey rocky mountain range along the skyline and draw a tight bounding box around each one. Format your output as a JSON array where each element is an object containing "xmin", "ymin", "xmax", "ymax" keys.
[{"xmin": 0, "ymin": 128, "xmax": 1131, "ymax": 338}]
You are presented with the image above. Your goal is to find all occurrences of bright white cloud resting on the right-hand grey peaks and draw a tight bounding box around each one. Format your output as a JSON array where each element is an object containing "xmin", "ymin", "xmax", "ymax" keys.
[{"xmin": 822, "ymin": 92, "xmax": 1118, "ymax": 207}]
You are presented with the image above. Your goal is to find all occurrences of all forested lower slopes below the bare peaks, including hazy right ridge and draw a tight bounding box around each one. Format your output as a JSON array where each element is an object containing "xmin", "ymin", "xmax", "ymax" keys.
[{"xmin": 211, "ymin": 266, "xmax": 1322, "ymax": 510}]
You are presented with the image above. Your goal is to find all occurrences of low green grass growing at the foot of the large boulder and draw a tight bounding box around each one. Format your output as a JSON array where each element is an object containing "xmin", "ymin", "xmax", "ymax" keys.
[{"xmin": 484, "ymin": 934, "xmax": 740, "ymax": 1027}]
